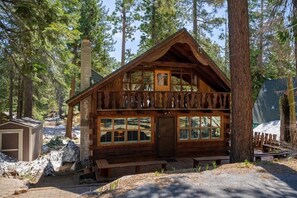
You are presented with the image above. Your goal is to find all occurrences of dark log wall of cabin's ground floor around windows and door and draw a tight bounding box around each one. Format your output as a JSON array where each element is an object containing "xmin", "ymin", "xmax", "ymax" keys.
[{"xmin": 90, "ymin": 111, "xmax": 230, "ymax": 162}]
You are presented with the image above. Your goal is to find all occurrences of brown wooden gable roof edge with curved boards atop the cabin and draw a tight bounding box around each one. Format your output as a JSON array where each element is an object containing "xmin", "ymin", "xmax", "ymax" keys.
[{"xmin": 66, "ymin": 28, "xmax": 231, "ymax": 106}]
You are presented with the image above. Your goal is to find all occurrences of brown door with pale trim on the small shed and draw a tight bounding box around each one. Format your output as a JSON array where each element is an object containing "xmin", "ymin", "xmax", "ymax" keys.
[{"xmin": 0, "ymin": 129, "xmax": 23, "ymax": 160}]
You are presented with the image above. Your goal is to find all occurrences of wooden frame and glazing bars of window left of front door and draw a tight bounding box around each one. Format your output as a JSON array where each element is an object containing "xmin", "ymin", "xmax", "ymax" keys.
[{"xmin": 96, "ymin": 115, "xmax": 155, "ymax": 146}]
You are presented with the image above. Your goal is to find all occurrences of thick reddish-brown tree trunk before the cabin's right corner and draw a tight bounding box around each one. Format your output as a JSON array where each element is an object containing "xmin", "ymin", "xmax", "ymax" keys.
[{"xmin": 228, "ymin": 0, "xmax": 254, "ymax": 162}]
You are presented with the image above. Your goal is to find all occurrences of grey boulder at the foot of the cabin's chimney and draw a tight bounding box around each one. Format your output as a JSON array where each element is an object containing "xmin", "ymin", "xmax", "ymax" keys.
[{"xmin": 61, "ymin": 141, "xmax": 80, "ymax": 163}]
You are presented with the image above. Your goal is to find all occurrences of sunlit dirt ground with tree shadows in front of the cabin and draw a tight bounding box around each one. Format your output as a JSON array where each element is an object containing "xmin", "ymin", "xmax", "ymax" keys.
[{"xmin": 97, "ymin": 159, "xmax": 297, "ymax": 198}]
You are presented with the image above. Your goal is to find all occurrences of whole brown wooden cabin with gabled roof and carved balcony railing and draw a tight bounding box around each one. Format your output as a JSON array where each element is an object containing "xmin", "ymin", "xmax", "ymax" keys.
[{"xmin": 67, "ymin": 29, "xmax": 230, "ymax": 162}]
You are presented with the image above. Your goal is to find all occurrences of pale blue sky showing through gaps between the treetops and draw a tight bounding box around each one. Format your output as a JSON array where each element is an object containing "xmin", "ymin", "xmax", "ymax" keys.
[{"xmin": 102, "ymin": 0, "xmax": 226, "ymax": 61}]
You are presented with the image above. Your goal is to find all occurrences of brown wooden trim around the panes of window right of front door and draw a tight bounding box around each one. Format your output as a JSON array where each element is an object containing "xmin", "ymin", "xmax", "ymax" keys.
[{"xmin": 176, "ymin": 114, "xmax": 224, "ymax": 143}]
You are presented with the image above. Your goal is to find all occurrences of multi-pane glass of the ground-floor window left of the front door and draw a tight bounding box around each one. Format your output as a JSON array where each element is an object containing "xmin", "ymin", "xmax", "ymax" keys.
[{"xmin": 98, "ymin": 117, "xmax": 152, "ymax": 145}]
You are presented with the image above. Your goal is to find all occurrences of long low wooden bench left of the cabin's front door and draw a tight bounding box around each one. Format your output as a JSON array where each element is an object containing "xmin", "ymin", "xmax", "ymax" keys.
[{"xmin": 96, "ymin": 159, "xmax": 167, "ymax": 177}]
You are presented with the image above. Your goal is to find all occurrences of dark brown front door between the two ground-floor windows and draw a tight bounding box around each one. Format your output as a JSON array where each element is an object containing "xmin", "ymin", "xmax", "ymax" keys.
[{"xmin": 157, "ymin": 116, "xmax": 176, "ymax": 157}]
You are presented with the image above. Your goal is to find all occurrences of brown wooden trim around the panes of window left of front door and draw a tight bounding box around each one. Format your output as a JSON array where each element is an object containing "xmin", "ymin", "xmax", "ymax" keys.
[{"xmin": 96, "ymin": 115, "xmax": 155, "ymax": 146}]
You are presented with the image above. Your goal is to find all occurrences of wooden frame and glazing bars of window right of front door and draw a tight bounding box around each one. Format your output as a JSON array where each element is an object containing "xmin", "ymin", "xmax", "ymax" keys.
[{"xmin": 176, "ymin": 114, "xmax": 224, "ymax": 142}]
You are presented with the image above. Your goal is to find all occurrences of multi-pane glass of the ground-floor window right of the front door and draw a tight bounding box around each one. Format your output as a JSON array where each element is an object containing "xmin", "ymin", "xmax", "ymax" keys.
[{"xmin": 178, "ymin": 116, "xmax": 221, "ymax": 141}]
